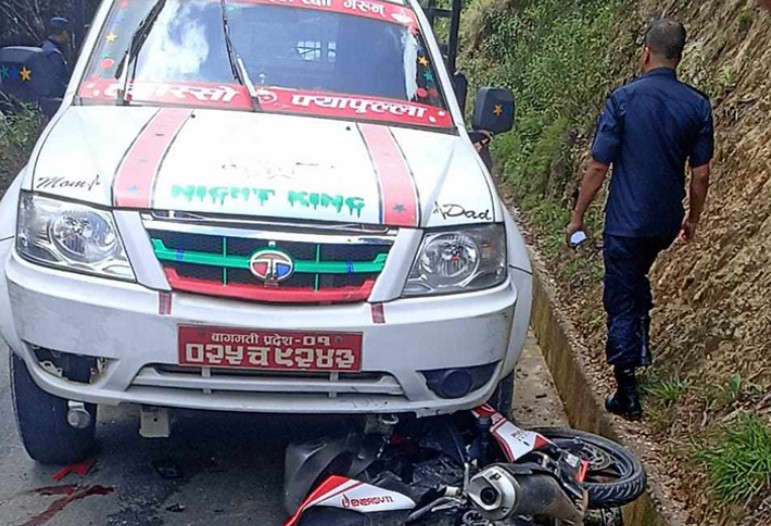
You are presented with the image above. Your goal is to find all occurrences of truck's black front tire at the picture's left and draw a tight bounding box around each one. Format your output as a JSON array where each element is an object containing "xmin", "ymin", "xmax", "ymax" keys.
[{"xmin": 10, "ymin": 352, "xmax": 96, "ymax": 464}]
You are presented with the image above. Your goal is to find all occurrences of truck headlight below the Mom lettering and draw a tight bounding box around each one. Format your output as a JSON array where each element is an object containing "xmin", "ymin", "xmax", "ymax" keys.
[{"xmin": 16, "ymin": 193, "xmax": 134, "ymax": 280}]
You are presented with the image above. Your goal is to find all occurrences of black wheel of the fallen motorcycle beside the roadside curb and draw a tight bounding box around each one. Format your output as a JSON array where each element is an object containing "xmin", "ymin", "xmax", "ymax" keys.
[{"xmin": 533, "ymin": 427, "xmax": 647, "ymax": 509}]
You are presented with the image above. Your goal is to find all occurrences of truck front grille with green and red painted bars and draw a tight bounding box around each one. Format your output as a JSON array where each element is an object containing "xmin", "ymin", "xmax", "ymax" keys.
[{"xmin": 145, "ymin": 221, "xmax": 392, "ymax": 303}]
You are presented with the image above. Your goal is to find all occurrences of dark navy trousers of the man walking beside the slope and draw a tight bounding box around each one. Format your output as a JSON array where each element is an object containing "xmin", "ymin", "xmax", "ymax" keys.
[{"xmin": 603, "ymin": 234, "xmax": 674, "ymax": 368}]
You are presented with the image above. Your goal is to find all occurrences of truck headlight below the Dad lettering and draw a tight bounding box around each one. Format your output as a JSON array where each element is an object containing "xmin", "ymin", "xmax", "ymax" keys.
[{"xmin": 404, "ymin": 225, "xmax": 506, "ymax": 296}]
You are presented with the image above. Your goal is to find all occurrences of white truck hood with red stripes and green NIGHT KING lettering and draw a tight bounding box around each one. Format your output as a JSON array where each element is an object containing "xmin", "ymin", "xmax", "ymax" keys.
[{"xmin": 27, "ymin": 106, "xmax": 501, "ymax": 227}]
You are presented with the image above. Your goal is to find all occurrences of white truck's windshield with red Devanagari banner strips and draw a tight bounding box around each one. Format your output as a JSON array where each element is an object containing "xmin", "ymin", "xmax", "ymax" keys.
[{"xmin": 80, "ymin": 0, "xmax": 449, "ymax": 129}]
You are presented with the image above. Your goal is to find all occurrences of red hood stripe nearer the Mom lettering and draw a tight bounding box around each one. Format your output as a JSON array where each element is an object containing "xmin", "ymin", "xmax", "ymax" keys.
[{"xmin": 113, "ymin": 108, "xmax": 192, "ymax": 208}]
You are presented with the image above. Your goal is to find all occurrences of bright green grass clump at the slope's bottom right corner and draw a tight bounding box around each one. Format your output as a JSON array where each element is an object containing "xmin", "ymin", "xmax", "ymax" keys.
[{"xmin": 697, "ymin": 414, "xmax": 771, "ymax": 504}]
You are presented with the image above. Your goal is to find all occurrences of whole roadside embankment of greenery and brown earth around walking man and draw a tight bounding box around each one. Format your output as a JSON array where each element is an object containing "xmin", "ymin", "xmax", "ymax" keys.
[{"xmin": 460, "ymin": 0, "xmax": 771, "ymax": 526}]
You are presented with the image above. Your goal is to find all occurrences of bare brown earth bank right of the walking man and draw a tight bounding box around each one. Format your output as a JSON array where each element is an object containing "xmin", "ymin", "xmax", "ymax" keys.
[{"xmin": 654, "ymin": 0, "xmax": 771, "ymax": 385}]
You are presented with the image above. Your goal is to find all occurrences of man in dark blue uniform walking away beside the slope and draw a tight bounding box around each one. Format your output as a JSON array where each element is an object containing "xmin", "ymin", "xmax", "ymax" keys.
[{"xmin": 566, "ymin": 19, "xmax": 714, "ymax": 420}]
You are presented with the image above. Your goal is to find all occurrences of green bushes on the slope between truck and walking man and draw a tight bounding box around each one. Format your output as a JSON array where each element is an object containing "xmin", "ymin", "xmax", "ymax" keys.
[{"xmin": 461, "ymin": 0, "xmax": 634, "ymax": 283}]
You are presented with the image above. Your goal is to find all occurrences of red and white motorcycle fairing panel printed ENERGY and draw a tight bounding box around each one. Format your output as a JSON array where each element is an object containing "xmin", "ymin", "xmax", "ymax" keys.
[{"xmin": 284, "ymin": 475, "xmax": 415, "ymax": 526}]
